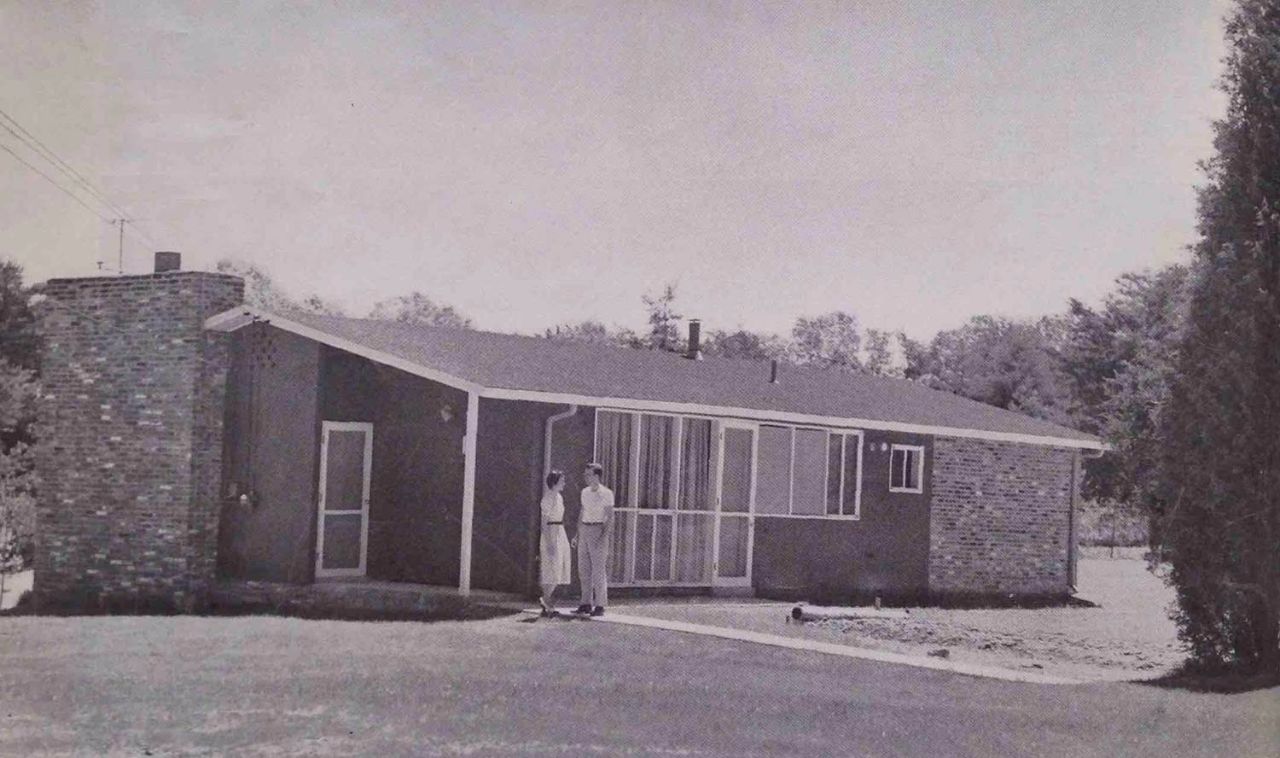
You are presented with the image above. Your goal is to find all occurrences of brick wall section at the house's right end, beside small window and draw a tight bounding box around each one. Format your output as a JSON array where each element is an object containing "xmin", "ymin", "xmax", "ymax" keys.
[{"xmin": 929, "ymin": 437, "xmax": 1075, "ymax": 597}]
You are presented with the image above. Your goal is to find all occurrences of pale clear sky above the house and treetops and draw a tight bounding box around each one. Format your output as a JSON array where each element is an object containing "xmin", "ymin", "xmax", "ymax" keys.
[{"xmin": 0, "ymin": 0, "xmax": 1228, "ymax": 338}]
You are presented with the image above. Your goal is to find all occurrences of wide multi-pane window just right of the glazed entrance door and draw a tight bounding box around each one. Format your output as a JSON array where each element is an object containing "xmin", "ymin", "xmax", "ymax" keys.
[{"xmin": 755, "ymin": 425, "xmax": 863, "ymax": 519}]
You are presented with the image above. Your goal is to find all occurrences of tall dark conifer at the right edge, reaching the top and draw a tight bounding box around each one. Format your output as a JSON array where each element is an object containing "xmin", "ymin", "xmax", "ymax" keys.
[{"xmin": 1146, "ymin": 0, "xmax": 1280, "ymax": 675}]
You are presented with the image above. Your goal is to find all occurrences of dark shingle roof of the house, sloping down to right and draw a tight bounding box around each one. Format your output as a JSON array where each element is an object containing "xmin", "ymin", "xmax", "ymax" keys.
[{"xmin": 240, "ymin": 307, "xmax": 1101, "ymax": 447}]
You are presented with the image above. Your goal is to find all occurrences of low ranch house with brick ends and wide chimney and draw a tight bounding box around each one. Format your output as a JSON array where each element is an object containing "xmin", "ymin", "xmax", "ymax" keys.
[{"xmin": 36, "ymin": 256, "xmax": 1102, "ymax": 604}]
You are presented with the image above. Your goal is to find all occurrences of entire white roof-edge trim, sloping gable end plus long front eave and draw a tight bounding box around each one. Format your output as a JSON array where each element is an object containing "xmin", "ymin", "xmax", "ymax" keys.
[{"xmin": 205, "ymin": 305, "xmax": 1108, "ymax": 452}]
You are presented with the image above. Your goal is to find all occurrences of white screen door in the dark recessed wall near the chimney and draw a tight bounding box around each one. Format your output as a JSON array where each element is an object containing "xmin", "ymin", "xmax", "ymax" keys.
[{"xmin": 316, "ymin": 421, "xmax": 374, "ymax": 576}]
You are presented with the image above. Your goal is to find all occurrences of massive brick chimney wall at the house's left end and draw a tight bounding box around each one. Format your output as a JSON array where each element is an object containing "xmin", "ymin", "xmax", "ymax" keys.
[{"xmin": 35, "ymin": 271, "xmax": 243, "ymax": 607}]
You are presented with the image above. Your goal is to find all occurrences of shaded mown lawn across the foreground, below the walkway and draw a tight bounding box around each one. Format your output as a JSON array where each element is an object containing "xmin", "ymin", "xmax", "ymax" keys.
[{"xmin": 0, "ymin": 604, "xmax": 1280, "ymax": 757}]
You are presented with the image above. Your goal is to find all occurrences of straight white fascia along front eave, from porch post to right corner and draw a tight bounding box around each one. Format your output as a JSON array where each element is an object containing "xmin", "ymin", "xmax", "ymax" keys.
[{"xmin": 480, "ymin": 387, "xmax": 1107, "ymax": 451}]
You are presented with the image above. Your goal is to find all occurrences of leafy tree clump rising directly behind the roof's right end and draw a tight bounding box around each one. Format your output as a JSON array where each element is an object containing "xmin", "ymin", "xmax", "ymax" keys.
[{"xmin": 902, "ymin": 316, "xmax": 1070, "ymax": 423}]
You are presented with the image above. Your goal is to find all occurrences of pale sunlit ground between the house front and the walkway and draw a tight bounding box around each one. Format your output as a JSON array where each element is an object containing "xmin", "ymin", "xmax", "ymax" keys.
[{"xmin": 614, "ymin": 560, "xmax": 1184, "ymax": 681}]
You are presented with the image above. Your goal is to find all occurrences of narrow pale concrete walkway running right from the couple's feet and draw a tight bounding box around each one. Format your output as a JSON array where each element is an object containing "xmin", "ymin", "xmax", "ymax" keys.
[{"xmin": 522, "ymin": 608, "xmax": 1083, "ymax": 684}]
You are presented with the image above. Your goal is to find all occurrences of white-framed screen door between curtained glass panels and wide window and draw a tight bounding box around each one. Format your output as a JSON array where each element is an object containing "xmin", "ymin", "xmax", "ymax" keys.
[{"xmin": 716, "ymin": 421, "xmax": 755, "ymax": 585}]
